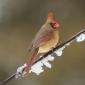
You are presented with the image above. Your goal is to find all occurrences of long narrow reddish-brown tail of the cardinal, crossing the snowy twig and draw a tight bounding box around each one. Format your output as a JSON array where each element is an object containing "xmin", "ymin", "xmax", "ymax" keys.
[{"xmin": 22, "ymin": 48, "xmax": 38, "ymax": 76}]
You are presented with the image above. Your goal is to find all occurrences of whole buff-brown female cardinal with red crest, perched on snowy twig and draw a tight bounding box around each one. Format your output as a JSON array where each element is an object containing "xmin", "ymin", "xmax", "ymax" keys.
[{"xmin": 22, "ymin": 13, "xmax": 59, "ymax": 76}]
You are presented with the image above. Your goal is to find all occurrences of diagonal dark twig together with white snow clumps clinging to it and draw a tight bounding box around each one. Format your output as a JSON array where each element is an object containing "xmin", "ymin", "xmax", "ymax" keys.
[{"xmin": 0, "ymin": 29, "xmax": 85, "ymax": 85}]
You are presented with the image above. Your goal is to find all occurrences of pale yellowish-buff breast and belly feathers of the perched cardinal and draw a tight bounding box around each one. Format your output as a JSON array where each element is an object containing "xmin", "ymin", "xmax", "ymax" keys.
[{"xmin": 38, "ymin": 31, "xmax": 59, "ymax": 53}]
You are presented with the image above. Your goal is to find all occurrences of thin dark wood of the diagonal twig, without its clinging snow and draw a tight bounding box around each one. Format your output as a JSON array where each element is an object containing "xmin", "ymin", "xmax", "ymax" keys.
[{"xmin": 0, "ymin": 29, "xmax": 85, "ymax": 85}]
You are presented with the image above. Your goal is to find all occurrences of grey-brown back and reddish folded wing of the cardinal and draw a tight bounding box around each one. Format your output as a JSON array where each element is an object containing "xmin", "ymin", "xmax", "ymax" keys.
[{"xmin": 32, "ymin": 25, "xmax": 53, "ymax": 48}]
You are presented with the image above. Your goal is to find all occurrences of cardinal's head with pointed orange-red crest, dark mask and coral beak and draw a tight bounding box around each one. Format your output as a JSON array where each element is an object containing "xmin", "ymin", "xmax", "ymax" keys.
[{"xmin": 46, "ymin": 12, "xmax": 59, "ymax": 29}]
